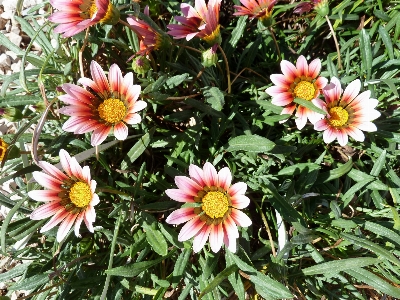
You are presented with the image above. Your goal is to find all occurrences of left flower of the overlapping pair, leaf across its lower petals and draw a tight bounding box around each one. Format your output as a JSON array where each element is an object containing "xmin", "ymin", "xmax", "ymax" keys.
[{"xmin": 265, "ymin": 55, "xmax": 328, "ymax": 129}]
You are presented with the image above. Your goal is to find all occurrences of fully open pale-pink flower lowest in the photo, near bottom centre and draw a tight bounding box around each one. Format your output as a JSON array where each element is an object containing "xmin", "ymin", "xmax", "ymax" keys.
[{"xmin": 165, "ymin": 162, "xmax": 251, "ymax": 252}]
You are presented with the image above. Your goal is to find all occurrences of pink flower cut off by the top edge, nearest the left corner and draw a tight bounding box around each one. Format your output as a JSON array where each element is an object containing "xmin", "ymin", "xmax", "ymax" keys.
[{"xmin": 49, "ymin": 0, "xmax": 119, "ymax": 37}]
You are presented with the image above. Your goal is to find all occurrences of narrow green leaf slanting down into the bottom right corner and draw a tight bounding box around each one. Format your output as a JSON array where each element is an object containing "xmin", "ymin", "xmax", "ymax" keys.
[{"xmin": 345, "ymin": 268, "xmax": 400, "ymax": 299}]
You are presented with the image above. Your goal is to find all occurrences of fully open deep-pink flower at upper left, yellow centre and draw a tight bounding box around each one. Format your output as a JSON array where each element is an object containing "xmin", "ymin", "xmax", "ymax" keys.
[{"xmin": 58, "ymin": 61, "xmax": 147, "ymax": 146}]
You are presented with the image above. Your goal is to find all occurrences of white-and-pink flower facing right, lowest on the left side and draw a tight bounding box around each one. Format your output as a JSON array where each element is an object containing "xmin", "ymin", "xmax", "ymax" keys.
[{"xmin": 28, "ymin": 149, "xmax": 100, "ymax": 242}]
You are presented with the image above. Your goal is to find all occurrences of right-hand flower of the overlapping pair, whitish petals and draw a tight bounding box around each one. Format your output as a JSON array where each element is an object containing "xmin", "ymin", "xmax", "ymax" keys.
[{"xmin": 314, "ymin": 77, "xmax": 381, "ymax": 146}]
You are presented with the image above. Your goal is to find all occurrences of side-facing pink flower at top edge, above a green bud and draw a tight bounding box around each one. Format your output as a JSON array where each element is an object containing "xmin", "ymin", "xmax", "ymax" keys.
[{"xmin": 167, "ymin": 0, "xmax": 222, "ymax": 45}]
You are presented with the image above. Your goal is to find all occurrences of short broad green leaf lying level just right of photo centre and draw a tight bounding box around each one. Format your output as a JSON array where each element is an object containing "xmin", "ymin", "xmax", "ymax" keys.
[{"xmin": 226, "ymin": 135, "xmax": 275, "ymax": 153}]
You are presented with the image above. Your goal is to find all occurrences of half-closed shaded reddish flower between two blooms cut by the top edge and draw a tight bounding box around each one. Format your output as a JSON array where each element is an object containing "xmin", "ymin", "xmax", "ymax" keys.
[{"xmin": 126, "ymin": 5, "xmax": 163, "ymax": 55}]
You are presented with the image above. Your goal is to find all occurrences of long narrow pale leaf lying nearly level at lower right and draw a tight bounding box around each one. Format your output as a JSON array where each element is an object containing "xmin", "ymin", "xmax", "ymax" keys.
[{"xmin": 302, "ymin": 257, "xmax": 381, "ymax": 276}]
